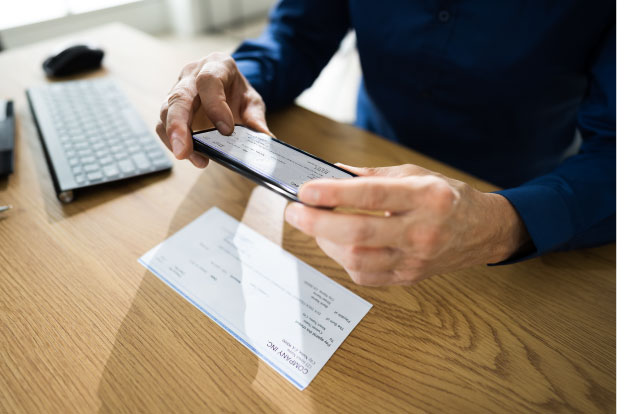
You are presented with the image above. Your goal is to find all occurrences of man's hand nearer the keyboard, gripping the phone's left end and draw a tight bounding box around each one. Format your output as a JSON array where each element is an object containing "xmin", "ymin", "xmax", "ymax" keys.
[{"xmin": 156, "ymin": 53, "xmax": 273, "ymax": 168}]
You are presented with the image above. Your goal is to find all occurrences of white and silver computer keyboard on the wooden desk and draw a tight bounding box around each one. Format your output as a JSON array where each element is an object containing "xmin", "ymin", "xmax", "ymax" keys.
[{"xmin": 27, "ymin": 78, "xmax": 172, "ymax": 202}]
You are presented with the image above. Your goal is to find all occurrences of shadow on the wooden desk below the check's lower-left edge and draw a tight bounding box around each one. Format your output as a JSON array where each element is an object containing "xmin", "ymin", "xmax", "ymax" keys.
[{"xmin": 98, "ymin": 272, "xmax": 280, "ymax": 412}]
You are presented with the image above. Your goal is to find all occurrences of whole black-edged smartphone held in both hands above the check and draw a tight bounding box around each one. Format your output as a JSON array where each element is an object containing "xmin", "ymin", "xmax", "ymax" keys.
[{"xmin": 192, "ymin": 125, "xmax": 356, "ymax": 203}]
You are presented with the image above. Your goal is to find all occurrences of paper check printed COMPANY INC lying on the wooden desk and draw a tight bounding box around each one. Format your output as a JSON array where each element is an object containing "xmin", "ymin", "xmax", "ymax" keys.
[{"xmin": 139, "ymin": 207, "xmax": 371, "ymax": 390}]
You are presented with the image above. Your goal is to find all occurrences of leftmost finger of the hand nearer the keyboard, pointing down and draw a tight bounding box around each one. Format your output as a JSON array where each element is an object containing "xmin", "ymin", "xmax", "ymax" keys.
[{"xmin": 166, "ymin": 77, "xmax": 198, "ymax": 159}]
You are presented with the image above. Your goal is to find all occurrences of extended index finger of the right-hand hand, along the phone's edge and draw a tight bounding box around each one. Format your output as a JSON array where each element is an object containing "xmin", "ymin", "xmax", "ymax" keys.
[{"xmin": 298, "ymin": 177, "xmax": 435, "ymax": 212}]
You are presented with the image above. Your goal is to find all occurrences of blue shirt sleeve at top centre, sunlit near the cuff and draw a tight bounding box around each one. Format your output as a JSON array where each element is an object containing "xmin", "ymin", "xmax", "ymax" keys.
[{"xmin": 233, "ymin": 0, "xmax": 349, "ymax": 109}]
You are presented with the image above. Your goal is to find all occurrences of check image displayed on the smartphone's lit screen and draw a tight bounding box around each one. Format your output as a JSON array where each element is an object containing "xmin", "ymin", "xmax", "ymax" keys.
[{"xmin": 193, "ymin": 126, "xmax": 353, "ymax": 194}]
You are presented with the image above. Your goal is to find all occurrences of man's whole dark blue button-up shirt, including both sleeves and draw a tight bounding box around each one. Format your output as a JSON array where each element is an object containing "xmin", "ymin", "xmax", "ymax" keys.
[{"xmin": 233, "ymin": 0, "xmax": 616, "ymax": 255}]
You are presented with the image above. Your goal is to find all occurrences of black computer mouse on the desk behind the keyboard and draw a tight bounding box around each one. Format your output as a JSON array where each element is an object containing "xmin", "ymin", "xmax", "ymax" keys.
[{"xmin": 42, "ymin": 45, "xmax": 104, "ymax": 77}]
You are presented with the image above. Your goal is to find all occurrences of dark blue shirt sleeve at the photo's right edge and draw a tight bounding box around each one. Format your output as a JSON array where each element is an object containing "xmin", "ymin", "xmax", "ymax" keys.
[{"xmin": 498, "ymin": 24, "xmax": 616, "ymax": 261}]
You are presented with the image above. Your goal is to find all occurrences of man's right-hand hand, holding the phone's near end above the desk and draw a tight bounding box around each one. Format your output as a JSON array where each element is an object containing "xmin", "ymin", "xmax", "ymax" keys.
[{"xmin": 285, "ymin": 165, "xmax": 529, "ymax": 286}]
